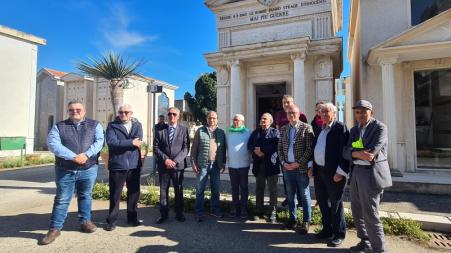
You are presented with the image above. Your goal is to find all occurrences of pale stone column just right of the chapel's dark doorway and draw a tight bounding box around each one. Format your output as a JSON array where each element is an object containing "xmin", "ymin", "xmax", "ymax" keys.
[{"xmin": 291, "ymin": 53, "xmax": 306, "ymax": 114}]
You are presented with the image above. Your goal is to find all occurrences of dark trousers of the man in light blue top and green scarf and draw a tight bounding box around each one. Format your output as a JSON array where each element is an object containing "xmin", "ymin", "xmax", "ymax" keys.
[{"xmin": 229, "ymin": 167, "xmax": 249, "ymax": 214}]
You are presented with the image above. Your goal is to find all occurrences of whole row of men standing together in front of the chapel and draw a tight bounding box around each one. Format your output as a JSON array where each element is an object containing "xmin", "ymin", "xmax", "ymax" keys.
[{"xmin": 41, "ymin": 95, "xmax": 391, "ymax": 252}]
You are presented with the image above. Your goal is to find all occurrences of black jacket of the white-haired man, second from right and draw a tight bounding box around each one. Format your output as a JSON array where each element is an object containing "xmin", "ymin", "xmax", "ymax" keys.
[{"xmin": 312, "ymin": 121, "xmax": 349, "ymax": 177}]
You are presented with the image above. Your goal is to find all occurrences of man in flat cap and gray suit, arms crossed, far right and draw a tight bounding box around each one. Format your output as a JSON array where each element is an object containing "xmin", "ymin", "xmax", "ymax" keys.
[{"xmin": 343, "ymin": 100, "xmax": 392, "ymax": 253}]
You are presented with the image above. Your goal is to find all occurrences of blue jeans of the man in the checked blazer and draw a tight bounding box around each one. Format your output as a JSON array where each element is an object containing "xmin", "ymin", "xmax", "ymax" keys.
[{"xmin": 283, "ymin": 170, "xmax": 312, "ymax": 222}]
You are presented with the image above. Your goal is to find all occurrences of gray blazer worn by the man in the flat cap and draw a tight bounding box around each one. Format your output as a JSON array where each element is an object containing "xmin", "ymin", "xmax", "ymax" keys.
[{"xmin": 343, "ymin": 119, "xmax": 392, "ymax": 190}]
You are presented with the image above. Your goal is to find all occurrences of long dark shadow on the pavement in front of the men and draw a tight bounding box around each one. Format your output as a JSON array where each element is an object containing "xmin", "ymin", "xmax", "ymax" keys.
[{"xmin": 0, "ymin": 205, "xmax": 354, "ymax": 253}]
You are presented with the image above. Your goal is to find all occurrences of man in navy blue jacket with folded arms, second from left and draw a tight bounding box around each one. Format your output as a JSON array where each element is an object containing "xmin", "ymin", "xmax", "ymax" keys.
[{"xmin": 106, "ymin": 104, "xmax": 143, "ymax": 231}]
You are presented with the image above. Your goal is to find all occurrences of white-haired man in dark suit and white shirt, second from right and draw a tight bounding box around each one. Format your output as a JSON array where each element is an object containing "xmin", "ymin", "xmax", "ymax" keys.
[{"xmin": 308, "ymin": 103, "xmax": 349, "ymax": 247}]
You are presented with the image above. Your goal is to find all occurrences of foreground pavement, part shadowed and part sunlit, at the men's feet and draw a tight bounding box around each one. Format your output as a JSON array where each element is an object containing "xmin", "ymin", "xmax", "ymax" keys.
[{"xmin": 0, "ymin": 200, "xmax": 439, "ymax": 253}]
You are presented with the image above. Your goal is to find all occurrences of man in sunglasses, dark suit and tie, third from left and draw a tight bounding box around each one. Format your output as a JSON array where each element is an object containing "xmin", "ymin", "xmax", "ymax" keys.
[{"xmin": 153, "ymin": 107, "xmax": 190, "ymax": 224}]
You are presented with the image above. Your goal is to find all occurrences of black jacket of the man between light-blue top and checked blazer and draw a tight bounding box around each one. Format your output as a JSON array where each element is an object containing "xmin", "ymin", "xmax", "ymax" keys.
[{"xmin": 247, "ymin": 127, "xmax": 280, "ymax": 177}]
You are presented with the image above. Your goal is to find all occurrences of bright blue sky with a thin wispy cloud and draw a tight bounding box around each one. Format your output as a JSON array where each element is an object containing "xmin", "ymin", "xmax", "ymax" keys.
[{"xmin": 0, "ymin": 0, "xmax": 349, "ymax": 98}]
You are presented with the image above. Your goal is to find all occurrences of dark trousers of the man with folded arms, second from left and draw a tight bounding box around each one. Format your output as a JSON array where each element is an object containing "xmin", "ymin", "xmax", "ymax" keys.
[{"xmin": 107, "ymin": 169, "xmax": 141, "ymax": 223}]
